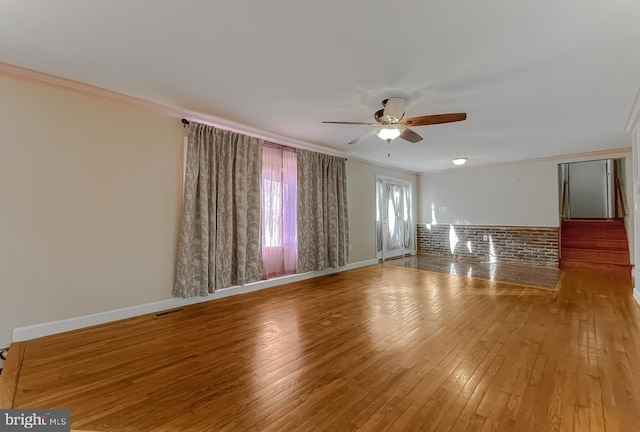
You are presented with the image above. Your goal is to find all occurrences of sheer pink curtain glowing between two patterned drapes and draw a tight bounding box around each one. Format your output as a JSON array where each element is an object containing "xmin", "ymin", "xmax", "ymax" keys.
[{"xmin": 261, "ymin": 143, "xmax": 298, "ymax": 279}]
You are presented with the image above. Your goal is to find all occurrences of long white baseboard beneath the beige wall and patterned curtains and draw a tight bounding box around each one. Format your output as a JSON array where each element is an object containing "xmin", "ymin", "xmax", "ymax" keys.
[{"xmin": 12, "ymin": 259, "xmax": 378, "ymax": 342}]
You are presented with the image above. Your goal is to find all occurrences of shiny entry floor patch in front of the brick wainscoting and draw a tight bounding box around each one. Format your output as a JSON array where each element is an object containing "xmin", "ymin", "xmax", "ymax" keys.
[{"xmin": 385, "ymin": 255, "xmax": 562, "ymax": 289}]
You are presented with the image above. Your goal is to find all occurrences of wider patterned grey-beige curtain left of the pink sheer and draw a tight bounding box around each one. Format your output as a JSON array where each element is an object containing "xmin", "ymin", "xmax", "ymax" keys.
[{"xmin": 173, "ymin": 122, "xmax": 262, "ymax": 297}]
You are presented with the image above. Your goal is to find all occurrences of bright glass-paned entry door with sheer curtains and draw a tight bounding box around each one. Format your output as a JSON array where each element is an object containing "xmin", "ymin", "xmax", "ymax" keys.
[{"xmin": 376, "ymin": 177, "xmax": 414, "ymax": 260}]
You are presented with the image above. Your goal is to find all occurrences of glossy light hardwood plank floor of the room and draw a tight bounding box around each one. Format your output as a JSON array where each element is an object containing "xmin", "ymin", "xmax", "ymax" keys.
[{"xmin": 3, "ymin": 265, "xmax": 640, "ymax": 432}]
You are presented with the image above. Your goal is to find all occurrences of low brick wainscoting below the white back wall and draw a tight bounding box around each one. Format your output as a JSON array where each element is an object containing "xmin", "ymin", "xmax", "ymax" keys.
[{"xmin": 418, "ymin": 224, "xmax": 559, "ymax": 267}]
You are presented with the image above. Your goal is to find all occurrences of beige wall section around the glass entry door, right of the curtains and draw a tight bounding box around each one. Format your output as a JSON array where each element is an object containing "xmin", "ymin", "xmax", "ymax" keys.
[{"xmin": 347, "ymin": 159, "xmax": 418, "ymax": 262}]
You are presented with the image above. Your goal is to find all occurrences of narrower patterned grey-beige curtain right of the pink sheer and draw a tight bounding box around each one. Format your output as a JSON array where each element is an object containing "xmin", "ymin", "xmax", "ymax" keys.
[{"xmin": 297, "ymin": 150, "xmax": 349, "ymax": 273}]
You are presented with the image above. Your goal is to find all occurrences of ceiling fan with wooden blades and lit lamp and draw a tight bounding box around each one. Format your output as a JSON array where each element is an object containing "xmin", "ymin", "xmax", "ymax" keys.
[{"xmin": 322, "ymin": 97, "xmax": 467, "ymax": 144}]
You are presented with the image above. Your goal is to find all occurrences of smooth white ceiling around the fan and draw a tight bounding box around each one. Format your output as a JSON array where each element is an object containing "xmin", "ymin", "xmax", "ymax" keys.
[{"xmin": 0, "ymin": 0, "xmax": 640, "ymax": 172}]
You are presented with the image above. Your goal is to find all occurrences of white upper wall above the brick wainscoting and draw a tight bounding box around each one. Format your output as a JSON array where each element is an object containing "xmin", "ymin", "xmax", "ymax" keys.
[{"xmin": 418, "ymin": 162, "xmax": 559, "ymax": 226}]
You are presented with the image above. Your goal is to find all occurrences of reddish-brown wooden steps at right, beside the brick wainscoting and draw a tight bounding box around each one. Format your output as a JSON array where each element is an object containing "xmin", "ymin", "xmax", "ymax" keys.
[{"xmin": 560, "ymin": 219, "xmax": 633, "ymax": 275}]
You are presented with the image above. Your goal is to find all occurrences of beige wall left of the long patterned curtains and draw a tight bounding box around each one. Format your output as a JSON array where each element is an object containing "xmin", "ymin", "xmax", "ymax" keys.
[{"xmin": 0, "ymin": 77, "xmax": 182, "ymax": 346}]
